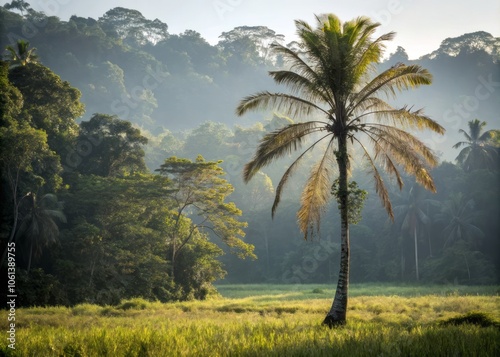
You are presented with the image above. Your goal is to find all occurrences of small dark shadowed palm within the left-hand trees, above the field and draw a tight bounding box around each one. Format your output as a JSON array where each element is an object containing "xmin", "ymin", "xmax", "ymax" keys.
[{"xmin": 16, "ymin": 193, "xmax": 66, "ymax": 272}]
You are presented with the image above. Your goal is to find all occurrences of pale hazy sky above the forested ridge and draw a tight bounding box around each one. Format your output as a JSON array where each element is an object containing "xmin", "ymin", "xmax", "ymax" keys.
[{"xmin": 28, "ymin": 0, "xmax": 500, "ymax": 59}]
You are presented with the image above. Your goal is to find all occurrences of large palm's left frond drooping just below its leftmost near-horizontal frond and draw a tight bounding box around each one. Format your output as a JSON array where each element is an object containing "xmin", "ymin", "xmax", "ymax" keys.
[{"xmin": 243, "ymin": 121, "xmax": 324, "ymax": 182}]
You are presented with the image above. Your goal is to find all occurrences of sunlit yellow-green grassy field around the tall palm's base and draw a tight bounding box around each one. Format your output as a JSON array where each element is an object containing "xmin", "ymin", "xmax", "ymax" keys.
[{"xmin": 0, "ymin": 285, "xmax": 500, "ymax": 357}]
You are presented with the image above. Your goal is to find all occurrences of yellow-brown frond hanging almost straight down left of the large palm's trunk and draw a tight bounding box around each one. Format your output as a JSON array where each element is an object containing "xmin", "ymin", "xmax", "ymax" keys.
[{"xmin": 297, "ymin": 140, "xmax": 335, "ymax": 240}]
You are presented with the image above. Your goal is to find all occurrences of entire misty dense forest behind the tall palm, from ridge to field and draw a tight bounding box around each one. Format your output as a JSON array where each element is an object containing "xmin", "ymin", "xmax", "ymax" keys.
[{"xmin": 0, "ymin": 1, "xmax": 500, "ymax": 306}]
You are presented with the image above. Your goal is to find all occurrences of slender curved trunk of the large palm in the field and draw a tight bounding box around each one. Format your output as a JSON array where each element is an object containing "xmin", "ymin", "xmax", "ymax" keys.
[{"xmin": 323, "ymin": 137, "xmax": 350, "ymax": 328}]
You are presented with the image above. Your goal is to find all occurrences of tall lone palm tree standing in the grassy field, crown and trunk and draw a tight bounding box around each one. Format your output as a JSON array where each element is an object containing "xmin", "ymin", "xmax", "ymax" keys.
[{"xmin": 236, "ymin": 15, "xmax": 444, "ymax": 327}]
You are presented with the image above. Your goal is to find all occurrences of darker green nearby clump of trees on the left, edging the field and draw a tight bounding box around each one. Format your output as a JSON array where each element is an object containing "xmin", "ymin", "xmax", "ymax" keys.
[{"xmin": 0, "ymin": 59, "xmax": 254, "ymax": 306}]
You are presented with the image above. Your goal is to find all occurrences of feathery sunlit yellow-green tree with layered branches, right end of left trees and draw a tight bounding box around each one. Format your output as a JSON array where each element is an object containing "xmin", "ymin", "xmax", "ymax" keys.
[{"xmin": 156, "ymin": 155, "xmax": 255, "ymax": 276}]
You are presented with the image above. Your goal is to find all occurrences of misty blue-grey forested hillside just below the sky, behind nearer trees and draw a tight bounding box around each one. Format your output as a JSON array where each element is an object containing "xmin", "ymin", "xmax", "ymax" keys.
[{"xmin": 0, "ymin": 6, "xmax": 500, "ymax": 160}]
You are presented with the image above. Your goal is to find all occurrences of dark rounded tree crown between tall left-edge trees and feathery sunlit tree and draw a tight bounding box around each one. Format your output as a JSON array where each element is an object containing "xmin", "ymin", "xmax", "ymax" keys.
[{"xmin": 75, "ymin": 114, "xmax": 148, "ymax": 176}]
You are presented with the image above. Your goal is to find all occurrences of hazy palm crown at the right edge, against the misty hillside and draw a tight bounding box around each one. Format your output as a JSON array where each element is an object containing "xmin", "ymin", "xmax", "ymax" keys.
[{"xmin": 453, "ymin": 119, "xmax": 500, "ymax": 172}]
